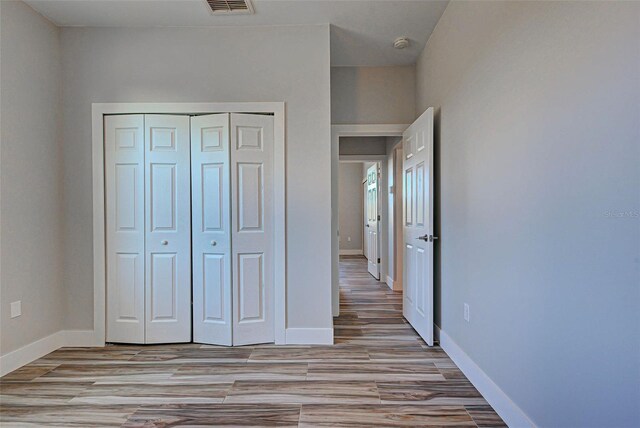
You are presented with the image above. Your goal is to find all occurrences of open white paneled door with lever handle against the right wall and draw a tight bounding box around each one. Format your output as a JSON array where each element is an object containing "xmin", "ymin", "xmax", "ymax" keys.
[{"xmin": 402, "ymin": 107, "xmax": 437, "ymax": 346}]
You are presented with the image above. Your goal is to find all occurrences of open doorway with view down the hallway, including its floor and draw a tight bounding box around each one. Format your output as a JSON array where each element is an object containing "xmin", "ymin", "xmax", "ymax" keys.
[{"xmin": 334, "ymin": 131, "xmax": 408, "ymax": 345}]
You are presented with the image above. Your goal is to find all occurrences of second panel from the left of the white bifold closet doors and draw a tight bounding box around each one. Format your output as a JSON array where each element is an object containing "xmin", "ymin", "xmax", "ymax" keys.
[{"xmin": 144, "ymin": 115, "xmax": 191, "ymax": 343}]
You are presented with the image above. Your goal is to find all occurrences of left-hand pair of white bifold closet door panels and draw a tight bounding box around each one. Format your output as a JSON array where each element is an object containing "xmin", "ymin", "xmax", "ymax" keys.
[{"xmin": 105, "ymin": 115, "xmax": 191, "ymax": 343}]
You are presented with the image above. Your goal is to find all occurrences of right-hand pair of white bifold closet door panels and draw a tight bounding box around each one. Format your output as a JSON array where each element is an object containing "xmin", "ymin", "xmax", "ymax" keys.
[{"xmin": 191, "ymin": 113, "xmax": 275, "ymax": 345}]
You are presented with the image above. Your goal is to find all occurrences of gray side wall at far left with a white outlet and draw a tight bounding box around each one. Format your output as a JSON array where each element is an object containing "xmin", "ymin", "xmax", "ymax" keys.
[{"xmin": 0, "ymin": 2, "xmax": 64, "ymax": 355}]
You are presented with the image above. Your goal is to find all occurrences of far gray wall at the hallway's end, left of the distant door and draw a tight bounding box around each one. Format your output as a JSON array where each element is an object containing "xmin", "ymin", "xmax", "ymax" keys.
[{"xmin": 338, "ymin": 162, "xmax": 364, "ymax": 251}]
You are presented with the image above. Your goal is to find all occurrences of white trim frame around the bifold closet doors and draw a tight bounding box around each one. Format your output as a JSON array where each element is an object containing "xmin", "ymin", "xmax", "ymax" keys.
[{"xmin": 91, "ymin": 102, "xmax": 287, "ymax": 346}]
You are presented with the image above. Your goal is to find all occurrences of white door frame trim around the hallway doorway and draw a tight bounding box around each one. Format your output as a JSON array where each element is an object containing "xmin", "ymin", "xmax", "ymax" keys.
[{"xmin": 331, "ymin": 124, "xmax": 409, "ymax": 317}]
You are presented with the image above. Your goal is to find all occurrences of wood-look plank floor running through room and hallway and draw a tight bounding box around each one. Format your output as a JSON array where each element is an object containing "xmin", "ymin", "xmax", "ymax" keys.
[{"xmin": 0, "ymin": 257, "xmax": 505, "ymax": 427}]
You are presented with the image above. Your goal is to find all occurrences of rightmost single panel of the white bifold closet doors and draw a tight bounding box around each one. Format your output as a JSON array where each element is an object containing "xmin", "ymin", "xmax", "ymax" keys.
[{"xmin": 231, "ymin": 113, "xmax": 275, "ymax": 345}]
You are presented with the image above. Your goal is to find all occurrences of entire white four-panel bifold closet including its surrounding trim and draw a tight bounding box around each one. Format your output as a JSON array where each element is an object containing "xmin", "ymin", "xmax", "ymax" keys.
[{"xmin": 92, "ymin": 103, "xmax": 286, "ymax": 346}]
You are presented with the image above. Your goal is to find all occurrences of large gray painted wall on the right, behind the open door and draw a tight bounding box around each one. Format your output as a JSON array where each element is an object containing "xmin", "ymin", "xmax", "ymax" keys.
[{"xmin": 416, "ymin": 2, "xmax": 640, "ymax": 427}]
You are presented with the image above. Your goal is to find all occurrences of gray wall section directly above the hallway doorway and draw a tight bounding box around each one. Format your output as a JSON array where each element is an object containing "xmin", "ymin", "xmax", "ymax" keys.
[{"xmin": 331, "ymin": 65, "xmax": 415, "ymax": 124}]
